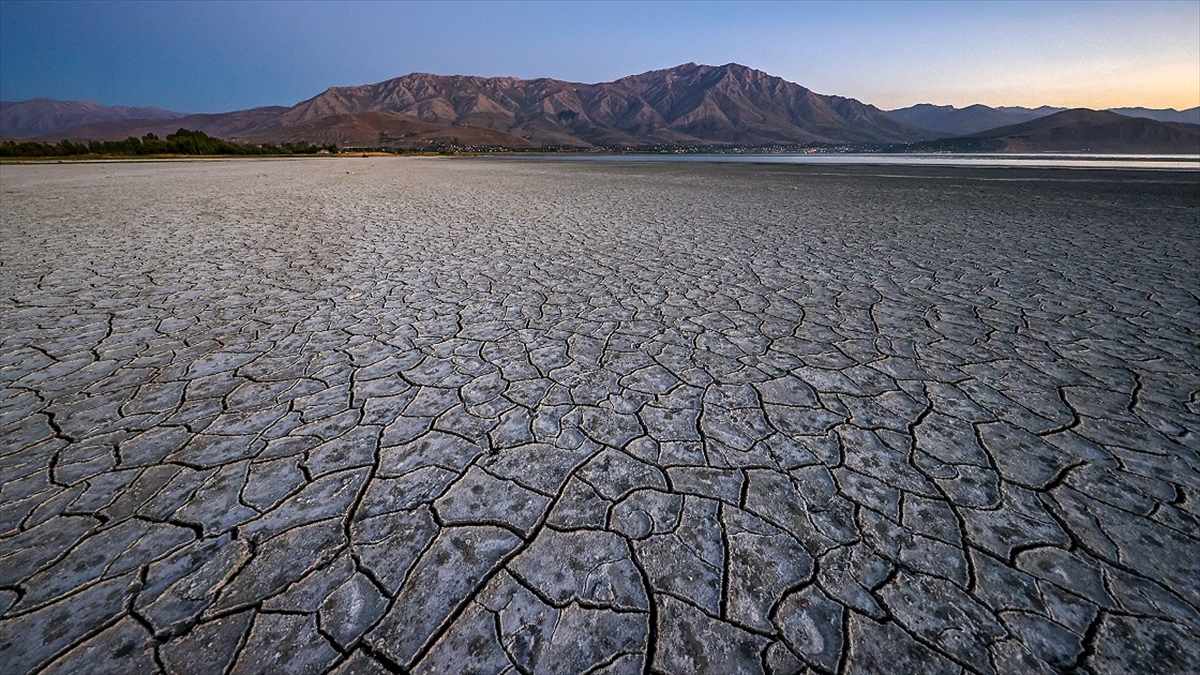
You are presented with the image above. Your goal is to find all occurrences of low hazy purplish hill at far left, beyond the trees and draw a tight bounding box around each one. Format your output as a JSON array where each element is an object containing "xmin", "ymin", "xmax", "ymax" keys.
[{"xmin": 0, "ymin": 98, "xmax": 184, "ymax": 138}]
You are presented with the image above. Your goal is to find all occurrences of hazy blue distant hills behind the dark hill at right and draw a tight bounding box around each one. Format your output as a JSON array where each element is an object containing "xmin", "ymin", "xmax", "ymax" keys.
[{"xmin": 887, "ymin": 103, "xmax": 1200, "ymax": 136}]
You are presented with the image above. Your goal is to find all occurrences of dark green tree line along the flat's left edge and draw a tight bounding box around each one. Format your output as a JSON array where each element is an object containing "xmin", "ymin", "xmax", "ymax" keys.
[{"xmin": 0, "ymin": 129, "xmax": 337, "ymax": 157}]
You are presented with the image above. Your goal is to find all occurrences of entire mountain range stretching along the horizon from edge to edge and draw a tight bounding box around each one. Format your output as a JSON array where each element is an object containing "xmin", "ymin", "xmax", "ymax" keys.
[{"xmin": 0, "ymin": 64, "xmax": 1200, "ymax": 151}]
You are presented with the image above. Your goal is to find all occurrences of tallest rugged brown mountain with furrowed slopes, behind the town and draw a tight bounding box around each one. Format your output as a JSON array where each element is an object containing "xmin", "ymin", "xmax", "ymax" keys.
[{"xmin": 0, "ymin": 62, "xmax": 928, "ymax": 148}]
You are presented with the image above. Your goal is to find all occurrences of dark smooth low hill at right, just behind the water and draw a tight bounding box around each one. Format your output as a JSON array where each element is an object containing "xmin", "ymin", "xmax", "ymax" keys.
[{"xmin": 961, "ymin": 108, "xmax": 1200, "ymax": 154}]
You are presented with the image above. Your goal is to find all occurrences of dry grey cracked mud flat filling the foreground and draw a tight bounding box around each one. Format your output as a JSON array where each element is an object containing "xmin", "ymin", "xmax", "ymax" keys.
[{"xmin": 0, "ymin": 159, "xmax": 1200, "ymax": 674}]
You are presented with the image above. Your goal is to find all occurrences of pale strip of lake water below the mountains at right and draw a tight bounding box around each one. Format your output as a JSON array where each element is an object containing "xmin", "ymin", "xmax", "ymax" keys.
[{"xmin": 516, "ymin": 153, "xmax": 1200, "ymax": 171}]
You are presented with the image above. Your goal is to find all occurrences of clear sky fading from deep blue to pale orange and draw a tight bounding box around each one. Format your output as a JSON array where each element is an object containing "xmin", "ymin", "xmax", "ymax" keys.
[{"xmin": 0, "ymin": 0, "xmax": 1200, "ymax": 112}]
